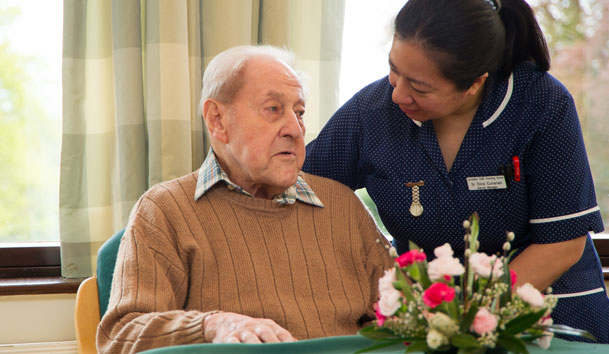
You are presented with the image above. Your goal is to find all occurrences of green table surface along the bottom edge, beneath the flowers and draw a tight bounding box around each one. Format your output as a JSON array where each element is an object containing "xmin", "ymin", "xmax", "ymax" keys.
[{"xmin": 143, "ymin": 335, "xmax": 609, "ymax": 354}]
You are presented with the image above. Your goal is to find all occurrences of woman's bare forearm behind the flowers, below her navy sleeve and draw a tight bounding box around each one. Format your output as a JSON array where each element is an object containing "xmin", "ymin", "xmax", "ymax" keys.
[{"xmin": 510, "ymin": 236, "xmax": 587, "ymax": 291}]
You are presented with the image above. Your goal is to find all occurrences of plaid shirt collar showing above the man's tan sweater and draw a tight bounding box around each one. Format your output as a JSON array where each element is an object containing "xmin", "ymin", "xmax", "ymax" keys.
[{"xmin": 195, "ymin": 149, "xmax": 324, "ymax": 208}]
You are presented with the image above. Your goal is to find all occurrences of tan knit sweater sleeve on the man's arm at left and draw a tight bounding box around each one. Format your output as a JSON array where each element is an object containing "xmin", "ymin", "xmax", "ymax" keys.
[{"xmin": 97, "ymin": 198, "xmax": 216, "ymax": 353}]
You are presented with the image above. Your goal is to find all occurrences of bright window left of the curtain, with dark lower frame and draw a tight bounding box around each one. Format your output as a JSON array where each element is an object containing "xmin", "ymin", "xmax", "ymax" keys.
[{"xmin": 0, "ymin": 0, "xmax": 63, "ymax": 282}]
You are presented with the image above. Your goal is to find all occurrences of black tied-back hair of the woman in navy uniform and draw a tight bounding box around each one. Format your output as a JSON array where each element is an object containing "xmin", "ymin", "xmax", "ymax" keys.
[{"xmin": 395, "ymin": 0, "xmax": 550, "ymax": 90}]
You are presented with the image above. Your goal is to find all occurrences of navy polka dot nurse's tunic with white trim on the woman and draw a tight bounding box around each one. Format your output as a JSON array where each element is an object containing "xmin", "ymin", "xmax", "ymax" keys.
[{"xmin": 303, "ymin": 63, "xmax": 609, "ymax": 343}]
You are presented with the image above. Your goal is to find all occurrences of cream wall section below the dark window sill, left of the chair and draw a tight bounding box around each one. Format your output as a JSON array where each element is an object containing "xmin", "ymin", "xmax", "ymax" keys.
[{"xmin": 0, "ymin": 294, "xmax": 76, "ymax": 344}]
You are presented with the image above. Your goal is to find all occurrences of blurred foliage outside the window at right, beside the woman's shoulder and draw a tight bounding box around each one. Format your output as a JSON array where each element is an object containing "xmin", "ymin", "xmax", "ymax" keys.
[{"xmin": 530, "ymin": 0, "xmax": 609, "ymax": 225}]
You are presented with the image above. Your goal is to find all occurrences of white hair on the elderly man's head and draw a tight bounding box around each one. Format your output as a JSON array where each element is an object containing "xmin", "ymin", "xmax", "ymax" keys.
[{"xmin": 199, "ymin": 45, "xmax": 306, "ymax": 116}]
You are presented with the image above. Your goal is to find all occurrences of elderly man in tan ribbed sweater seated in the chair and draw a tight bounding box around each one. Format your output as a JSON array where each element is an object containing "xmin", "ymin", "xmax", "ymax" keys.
[{"xmin": 97, "ymin": 46, "xmax": 392, "ymax": 353}]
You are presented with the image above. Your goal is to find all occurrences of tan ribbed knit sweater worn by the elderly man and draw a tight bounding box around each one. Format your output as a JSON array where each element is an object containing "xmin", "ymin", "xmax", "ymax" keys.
[{"xmin": 97, "ymin": 173, "xmax": 392, "ymax": 353}]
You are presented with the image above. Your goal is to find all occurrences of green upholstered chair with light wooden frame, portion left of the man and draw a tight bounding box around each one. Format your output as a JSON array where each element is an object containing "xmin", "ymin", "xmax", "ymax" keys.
[{"xmin": 74, "ymin": 229, "xmax": 125, "ymax": 354}]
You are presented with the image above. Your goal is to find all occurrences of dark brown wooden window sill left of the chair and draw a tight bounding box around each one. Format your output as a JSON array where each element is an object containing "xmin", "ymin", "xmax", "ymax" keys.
[{"xmin": 0, "ymin": 277, "xmax": 83, "ymax": 296}]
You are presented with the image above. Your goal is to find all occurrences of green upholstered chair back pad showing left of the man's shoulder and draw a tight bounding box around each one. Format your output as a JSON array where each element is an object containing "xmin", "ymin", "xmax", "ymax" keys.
[{"xmin": 97, "ymin": 229, "xmax": 125, "ymax": 318}]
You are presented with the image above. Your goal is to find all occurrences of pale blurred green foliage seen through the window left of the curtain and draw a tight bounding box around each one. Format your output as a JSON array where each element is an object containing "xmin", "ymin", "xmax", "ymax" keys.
[{"xmin": 0, "ymin": 9, "xmax": 59, "ymax": 242}]
